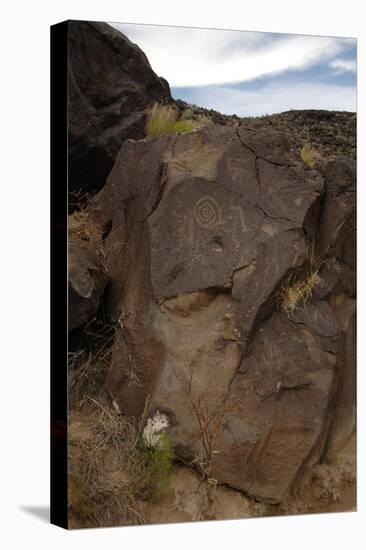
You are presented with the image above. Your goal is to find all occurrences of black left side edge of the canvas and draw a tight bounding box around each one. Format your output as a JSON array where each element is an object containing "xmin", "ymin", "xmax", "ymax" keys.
[{"xmin": 50, "ymin": 21, "xmax": 68, "ymax": 529}]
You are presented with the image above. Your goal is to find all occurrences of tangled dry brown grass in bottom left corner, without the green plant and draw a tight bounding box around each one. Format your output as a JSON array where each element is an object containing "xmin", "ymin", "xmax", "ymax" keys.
[{"xmin": 68, "ymin": 399, "xmax": 144, "ymax": 527}]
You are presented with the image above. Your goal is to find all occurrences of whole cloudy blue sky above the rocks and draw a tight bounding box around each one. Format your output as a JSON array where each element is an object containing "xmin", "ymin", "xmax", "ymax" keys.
[{"xmin": 111, "ymin": 23, "xmax": 357, "ymax": 116}]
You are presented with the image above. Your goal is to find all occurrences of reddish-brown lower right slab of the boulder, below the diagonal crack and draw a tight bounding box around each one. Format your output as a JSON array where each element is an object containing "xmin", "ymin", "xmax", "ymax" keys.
[{"xmin": 217, "ymin": 302, "xmax": 339, "ymax": 502}]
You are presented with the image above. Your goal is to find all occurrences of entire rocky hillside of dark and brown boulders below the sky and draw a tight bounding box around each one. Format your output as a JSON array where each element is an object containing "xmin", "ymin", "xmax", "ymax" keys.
[{"xmin": 69, "ymin": 23, "xmax": 356, "ymax": 532}]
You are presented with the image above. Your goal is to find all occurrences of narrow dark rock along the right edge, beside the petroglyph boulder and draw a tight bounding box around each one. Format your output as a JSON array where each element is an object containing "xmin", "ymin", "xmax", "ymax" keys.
[{"xmin": 317, "ymin": 155, "xmax": 356, "ymax": 453}]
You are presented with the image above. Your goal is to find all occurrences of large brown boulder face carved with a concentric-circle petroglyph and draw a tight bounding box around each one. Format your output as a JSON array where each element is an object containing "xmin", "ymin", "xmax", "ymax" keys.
[{"xmin": 93, "ymin": 125, "xmax": 352, "ymax": 502}]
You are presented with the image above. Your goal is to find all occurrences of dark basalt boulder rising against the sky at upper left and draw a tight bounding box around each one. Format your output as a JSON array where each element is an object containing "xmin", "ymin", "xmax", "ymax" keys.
[{"xmin": 68, "ymin": 21, "xmax": 171, "ymax": 198}]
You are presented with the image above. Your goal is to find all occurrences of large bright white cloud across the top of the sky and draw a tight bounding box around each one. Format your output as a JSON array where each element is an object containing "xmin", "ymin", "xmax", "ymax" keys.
[{"xmin": 113, "ymin": 23, "xmax": 355, "ymax": 87}]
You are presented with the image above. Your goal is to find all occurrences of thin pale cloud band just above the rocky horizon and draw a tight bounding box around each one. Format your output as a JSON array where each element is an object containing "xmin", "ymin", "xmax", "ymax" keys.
[{"xmin": 178, "ymin": 82, "xmax": 356, "ymax": 116}]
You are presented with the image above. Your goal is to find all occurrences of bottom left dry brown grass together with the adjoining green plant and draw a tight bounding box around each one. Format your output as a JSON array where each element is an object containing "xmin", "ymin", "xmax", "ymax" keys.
[{"xmin": 68, "ymin": 397, "xmax": 173, "ymax": 527}]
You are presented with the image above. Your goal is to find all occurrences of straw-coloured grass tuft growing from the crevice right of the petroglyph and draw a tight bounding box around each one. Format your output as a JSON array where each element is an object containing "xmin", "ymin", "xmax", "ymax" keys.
[{"xmin": 279, "ymin": 241, "xmax": 322, "ymax": 315}]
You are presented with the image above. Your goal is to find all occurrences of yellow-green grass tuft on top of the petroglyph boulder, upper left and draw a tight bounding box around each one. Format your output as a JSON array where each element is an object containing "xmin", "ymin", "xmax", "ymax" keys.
[{"xmin": 145, "ymin": 103, "xmax": 200, "ymax": 137}]
